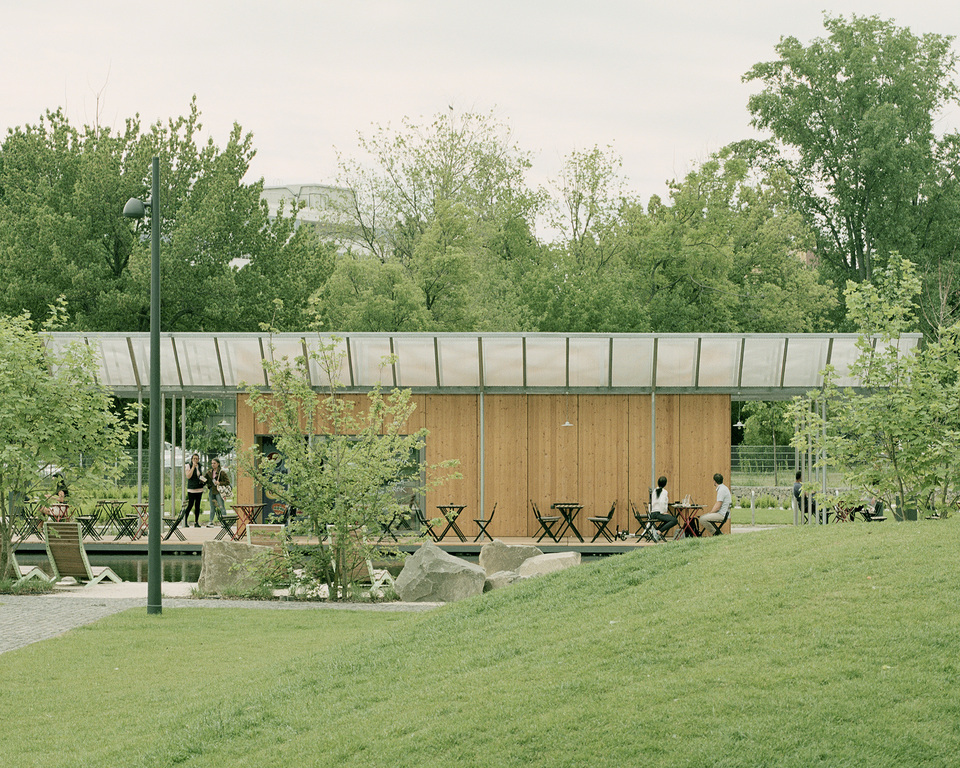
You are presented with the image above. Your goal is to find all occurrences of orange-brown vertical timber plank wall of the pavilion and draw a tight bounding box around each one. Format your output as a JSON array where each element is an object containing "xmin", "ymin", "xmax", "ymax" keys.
[{"xmin": 237, "ymin": 395, "xmax": 730, "ymax": 541}]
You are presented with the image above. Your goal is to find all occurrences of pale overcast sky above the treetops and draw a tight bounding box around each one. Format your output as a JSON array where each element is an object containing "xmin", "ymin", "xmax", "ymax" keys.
[{"xmin": 0, "ymin": 0, "xmax": 960, "ymax": 199}]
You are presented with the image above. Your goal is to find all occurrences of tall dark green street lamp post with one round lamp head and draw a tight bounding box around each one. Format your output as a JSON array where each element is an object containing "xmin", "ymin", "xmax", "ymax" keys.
[{"xmin": 123, "ymin": 156, "xmax": 163, "ymax": 613}]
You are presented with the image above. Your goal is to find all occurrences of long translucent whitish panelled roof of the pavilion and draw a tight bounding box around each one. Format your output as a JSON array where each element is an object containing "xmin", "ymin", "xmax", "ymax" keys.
[{"xmin": 47, "ymin": 333, "xmax": 921, "ymax": 399}]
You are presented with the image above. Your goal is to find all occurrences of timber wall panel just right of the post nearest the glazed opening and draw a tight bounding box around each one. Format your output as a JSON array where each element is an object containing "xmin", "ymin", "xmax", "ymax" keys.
[{"xmin": 484, "ymin": 395, "xmax": 536, "ymax": 538}]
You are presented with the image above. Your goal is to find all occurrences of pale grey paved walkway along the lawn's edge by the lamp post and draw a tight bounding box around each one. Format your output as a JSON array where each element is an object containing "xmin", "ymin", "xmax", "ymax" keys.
[{"xmin": 0, "ymin": 582, "xmax": 439, "ymax": 653}]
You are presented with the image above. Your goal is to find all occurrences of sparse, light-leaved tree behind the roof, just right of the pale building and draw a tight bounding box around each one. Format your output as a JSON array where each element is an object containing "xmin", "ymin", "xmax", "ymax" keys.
[{"xmin": 325, "ymin": 112, "xmax": 539, "ymax": 331}]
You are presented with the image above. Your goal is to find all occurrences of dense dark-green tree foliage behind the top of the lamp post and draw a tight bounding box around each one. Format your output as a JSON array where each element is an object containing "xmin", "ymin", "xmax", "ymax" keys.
[{"xmin": 0, "ymin": 99, "xmax": 308, "ymax": 331}]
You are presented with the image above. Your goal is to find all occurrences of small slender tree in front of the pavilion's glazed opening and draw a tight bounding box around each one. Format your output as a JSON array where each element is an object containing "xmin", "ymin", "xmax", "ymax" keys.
[{"xmin": 239, "ymin": 340, "xmax": 456, "ymax": 600}]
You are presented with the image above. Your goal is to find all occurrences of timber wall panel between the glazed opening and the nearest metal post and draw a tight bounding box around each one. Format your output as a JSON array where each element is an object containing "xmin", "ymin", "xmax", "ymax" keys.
[{"xmin": 423, "ymin": 395, "xmax": 480, "ymax": 528}]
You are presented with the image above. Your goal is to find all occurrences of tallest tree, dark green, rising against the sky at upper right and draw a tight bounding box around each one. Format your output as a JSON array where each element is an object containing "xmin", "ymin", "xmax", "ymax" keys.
[{"xmin": 743, "ymin": 15, "xmax": 957, "ymax": 294}]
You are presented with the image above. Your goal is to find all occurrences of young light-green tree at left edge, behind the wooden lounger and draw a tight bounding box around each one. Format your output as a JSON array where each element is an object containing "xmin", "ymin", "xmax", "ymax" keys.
[{"xmin": 0, "ymin": 305, "xmax": 131, "ymax": 578}]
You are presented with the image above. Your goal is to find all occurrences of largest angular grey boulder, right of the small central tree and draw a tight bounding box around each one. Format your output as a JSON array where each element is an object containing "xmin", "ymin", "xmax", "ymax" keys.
[{"xmin": 394, "ymin": 541, "xmax": 487, "ymax": 603}]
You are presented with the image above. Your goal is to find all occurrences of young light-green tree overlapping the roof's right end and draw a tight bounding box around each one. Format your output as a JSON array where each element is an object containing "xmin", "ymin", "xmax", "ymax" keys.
[{"xmin": 791, "ymin": 254, "xmax": 960, "ymax": 517}]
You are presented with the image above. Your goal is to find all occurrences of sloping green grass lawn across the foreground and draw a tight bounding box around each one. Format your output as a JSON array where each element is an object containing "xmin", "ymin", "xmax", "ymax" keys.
[{"xmin": 0, "ymin": 520, "xmax": 960, "ymax": 768}]
